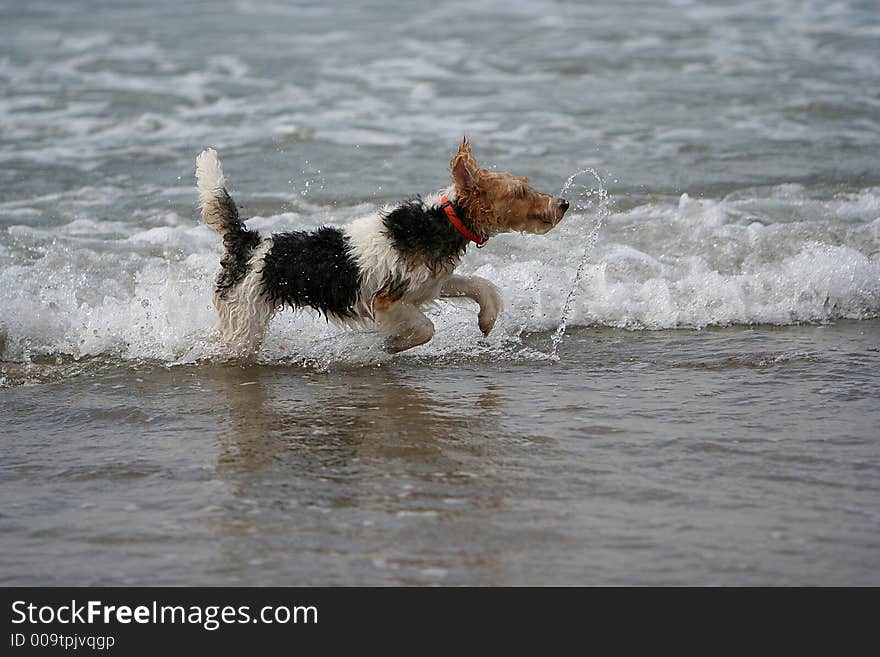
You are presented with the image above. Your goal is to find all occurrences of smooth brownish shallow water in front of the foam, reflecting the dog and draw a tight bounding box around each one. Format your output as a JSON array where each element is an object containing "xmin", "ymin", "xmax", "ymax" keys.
[{"xmin": 0, "ymin": 321, "xmax": 880, "ymax": 585}]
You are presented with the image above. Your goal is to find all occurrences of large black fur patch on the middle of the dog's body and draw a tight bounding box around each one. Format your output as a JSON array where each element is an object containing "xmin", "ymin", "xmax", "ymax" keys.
[{"xmin": 263, "ymin": 226, "xmax": 360, "ymax": 318}]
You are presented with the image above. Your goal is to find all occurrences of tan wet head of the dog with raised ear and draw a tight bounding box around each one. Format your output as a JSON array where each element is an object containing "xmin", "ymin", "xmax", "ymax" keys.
[{"xmin": 450, "ymin": 137, "xmax": 568, "ymax": 237}]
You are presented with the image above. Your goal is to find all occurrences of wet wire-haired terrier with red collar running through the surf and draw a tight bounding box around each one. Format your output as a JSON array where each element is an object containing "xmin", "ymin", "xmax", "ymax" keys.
[{"xmin": 196, "ymin": 137, "xmax": 569, "ymax": 357}]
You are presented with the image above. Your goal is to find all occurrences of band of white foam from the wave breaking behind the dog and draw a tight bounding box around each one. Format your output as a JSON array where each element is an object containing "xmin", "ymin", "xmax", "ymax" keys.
[{"xmin": 0, "ymin": 188, "xmax": 880, "ymax": 366}]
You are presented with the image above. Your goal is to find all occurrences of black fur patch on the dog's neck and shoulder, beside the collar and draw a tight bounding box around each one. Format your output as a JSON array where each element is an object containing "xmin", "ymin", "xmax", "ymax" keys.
[{"xmin": 383, "ymin": 198, "xmax": 469, "ymax": 271}]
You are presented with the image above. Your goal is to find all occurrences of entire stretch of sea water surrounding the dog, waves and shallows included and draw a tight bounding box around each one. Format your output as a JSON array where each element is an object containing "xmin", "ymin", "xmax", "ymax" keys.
[{"xmin": 0, "ymin": 0, "xmax": 880, "ymax": 584}]
